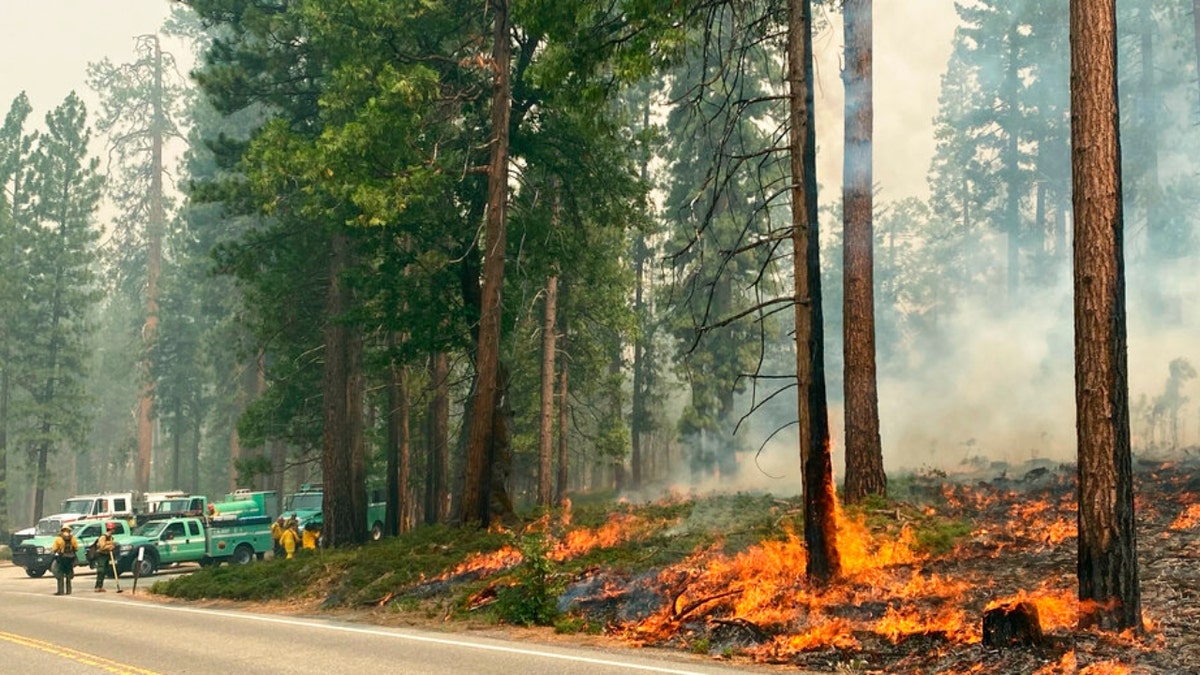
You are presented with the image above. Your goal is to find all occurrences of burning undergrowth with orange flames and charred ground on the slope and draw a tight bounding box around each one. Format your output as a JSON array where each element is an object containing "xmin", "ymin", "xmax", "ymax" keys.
[{"xmin": 381, "ymin": 454, "xmax": 1200, "ymax": 675}]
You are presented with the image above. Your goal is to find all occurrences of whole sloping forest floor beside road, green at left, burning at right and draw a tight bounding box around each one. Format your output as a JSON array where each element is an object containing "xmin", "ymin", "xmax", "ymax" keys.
[{"xmin": 152, "ymin": 455, "xmax": 1200, "ymax": 675}]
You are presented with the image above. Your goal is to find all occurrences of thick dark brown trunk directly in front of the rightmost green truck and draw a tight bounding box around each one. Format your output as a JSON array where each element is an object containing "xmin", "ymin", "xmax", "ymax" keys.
[{"xmin": 320, "ymin": 232, "xmax": 366, "ymax": 546}]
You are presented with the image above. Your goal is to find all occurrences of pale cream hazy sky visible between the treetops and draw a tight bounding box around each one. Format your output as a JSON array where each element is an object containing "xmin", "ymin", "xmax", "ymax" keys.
[{"xmin": 0, "ymin": 0, "xmax": 955, "ymax": 202}]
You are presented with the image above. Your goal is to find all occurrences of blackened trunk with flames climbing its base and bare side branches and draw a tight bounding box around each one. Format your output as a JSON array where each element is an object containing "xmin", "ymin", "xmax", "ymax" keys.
[{"xmin": 787, "ymin": 0, "xmax": 841, "ymax": 584}]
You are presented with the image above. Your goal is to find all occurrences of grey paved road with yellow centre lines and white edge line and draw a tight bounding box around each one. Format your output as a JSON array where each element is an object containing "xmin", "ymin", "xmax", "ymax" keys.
[{"xmin": 0, "ymin": 563, "xmax": 767, "ymax": 675}]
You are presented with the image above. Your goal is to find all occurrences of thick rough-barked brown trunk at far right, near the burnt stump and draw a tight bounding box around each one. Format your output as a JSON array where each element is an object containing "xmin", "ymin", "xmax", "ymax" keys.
[{"xmin": 1070, "ymin": 0, "xmax": 1141, "ymax": 631}]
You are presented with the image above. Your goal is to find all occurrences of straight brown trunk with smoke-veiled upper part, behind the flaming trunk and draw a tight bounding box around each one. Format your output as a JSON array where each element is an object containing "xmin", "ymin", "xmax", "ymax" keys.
[{"xmin": 842, "ymin": 0, "xmax": 888, "ymax": 502}]
